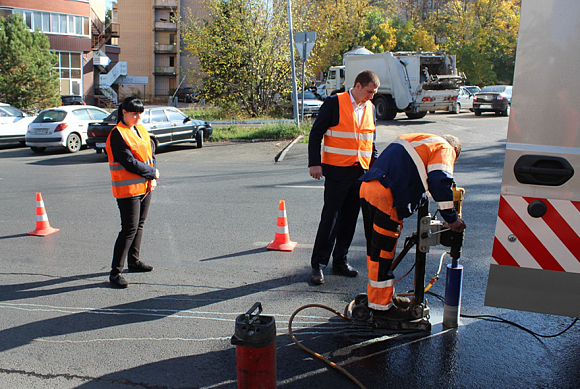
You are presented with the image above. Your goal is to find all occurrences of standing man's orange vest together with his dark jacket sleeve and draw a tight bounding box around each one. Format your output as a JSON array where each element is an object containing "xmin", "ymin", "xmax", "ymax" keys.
[{"xmin": 308, "ymin": 92, "xmax": 377, "ymax": 169}]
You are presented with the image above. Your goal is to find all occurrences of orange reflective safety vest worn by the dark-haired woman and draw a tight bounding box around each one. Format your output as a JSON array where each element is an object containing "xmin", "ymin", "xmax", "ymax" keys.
[{"xmin": 106, "ymin": 122, "xmax": 153, "ymax": 199}]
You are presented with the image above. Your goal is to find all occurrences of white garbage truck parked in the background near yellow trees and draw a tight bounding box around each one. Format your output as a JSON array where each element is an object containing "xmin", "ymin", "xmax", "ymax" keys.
[{"xmin": 326, "ymin": 50, "xmax": 463, "ymax": 120}]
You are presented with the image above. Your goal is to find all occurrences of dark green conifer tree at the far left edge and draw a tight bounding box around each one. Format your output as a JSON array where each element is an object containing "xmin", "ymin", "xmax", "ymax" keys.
[{"xmin": 0, "ymin": 13, "xmax": 60, "ymax": 112}]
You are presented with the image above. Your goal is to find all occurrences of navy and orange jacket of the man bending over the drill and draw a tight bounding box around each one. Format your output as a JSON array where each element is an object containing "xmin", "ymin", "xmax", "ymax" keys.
[{"xmin": 360, "ymin": 134, "xmax": 457, "ymax": 223}]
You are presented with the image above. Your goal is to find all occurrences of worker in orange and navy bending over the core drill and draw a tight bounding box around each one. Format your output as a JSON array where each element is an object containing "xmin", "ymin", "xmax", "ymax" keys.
[{"xmin": 360, "ymin": 134, "xmax": 465, "ymax": 320}]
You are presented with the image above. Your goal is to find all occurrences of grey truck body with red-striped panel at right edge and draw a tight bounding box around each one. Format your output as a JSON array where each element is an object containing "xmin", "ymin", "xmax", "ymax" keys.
[{"xmin": 485, "ymin": 0, "xmax": 580, "ymax": 317}]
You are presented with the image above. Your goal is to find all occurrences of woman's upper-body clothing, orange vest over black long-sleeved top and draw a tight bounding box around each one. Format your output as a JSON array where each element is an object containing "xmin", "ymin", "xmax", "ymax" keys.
[{"xmin": 106, "ymin": 122, "xmax": 155, "ymax": 199}]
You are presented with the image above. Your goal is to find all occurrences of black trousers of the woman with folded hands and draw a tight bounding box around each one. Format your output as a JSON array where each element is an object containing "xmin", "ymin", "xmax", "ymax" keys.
[{"xmin": 111, "ymin": 193, "xmax": 151, "ymax": 275}]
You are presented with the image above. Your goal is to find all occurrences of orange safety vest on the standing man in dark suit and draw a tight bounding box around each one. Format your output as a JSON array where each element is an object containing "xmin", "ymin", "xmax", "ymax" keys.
[{"xmin": 322, "ymin": 92, "xmax": 375, "ymax": 169}]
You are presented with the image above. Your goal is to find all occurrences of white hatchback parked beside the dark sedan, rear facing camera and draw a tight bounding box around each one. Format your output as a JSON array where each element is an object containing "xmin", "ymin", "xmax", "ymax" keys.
[{"xmin": 26, "ymin": 105, "xmax": 109, "ymax": 153}]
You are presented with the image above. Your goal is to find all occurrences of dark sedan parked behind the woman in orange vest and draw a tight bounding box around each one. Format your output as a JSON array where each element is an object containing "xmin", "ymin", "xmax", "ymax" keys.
[{"xmin": 87, "ymin": 107, "xmax": 213, "ymax": 154}]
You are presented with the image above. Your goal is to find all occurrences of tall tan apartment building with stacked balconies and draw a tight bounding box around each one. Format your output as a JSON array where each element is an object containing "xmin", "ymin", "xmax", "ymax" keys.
[{"xmin": 117, "ymin": 0, "xmax": 202, "ymax": 99}]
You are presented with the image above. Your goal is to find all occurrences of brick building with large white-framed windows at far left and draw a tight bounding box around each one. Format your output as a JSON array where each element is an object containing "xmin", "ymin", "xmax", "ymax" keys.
[{"xmin": 0, "ymin": 0, "xmax": 126, "ymax": 105}]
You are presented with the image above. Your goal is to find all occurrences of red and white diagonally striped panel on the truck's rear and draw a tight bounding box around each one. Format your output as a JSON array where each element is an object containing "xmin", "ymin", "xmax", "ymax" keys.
[{"xmin": 492, "ymin": 196, "xmax": 580, "ymax": 273}]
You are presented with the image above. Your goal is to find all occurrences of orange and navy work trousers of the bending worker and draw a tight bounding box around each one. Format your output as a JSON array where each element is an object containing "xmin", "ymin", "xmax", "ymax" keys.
[{"xmin": 360, "ymin": 180, "xmax": 403, "ymax": 311}]
